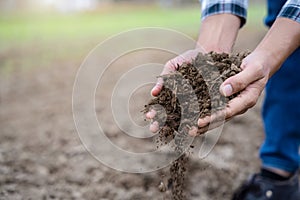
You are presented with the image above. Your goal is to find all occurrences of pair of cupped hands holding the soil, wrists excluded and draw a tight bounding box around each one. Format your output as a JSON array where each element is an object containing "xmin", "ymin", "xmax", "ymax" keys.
[{"xmin": 146, "ymin": 50, "xmax": 270, "ymax": 136}]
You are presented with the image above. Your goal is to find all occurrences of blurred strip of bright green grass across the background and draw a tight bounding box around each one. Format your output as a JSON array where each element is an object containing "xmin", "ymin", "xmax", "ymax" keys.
[{"xmin": 0, "ymin": 5, "xmax": 264, "ymax": 46}]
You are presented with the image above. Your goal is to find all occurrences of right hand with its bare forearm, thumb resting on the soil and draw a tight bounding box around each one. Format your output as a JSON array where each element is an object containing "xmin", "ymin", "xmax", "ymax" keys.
[{"xmin": 198, "ymin": 18, "xmax": 300, "ymax": 134}]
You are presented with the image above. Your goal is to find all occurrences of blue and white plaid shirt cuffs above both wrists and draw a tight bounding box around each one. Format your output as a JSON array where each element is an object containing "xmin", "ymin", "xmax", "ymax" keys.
[{"xmin": 201, "ymin": 0, "xmax": 300, "ymax": 26}]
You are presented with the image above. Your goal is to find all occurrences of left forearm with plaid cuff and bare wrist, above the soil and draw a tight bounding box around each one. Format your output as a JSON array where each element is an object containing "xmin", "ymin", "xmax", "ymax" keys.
[{"xmin": 198, "ymin": 0, "xmax": 248, "ymax": 53}]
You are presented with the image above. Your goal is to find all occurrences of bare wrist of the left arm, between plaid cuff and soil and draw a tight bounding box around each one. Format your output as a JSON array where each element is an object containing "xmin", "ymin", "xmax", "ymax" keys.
[{"xmin": 197, "ymin": 14, "xmax": 241, "ymax": 53}]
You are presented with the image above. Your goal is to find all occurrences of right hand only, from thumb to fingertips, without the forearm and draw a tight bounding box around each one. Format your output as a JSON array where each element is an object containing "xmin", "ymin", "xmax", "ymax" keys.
[{"xmin": 198, "ymin": 51, "xmax": 270, "ymax": 136}]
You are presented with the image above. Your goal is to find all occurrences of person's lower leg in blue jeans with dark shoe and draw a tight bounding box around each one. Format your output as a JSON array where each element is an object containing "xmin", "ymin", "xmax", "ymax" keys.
[{"xmin": 232, "ymin": 48, "xmax": 300, "ymax": 200}]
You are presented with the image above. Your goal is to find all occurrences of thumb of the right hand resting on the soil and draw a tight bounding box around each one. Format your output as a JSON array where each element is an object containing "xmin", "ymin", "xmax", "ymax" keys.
[{"xmin": 220, "ymin": 62, "xmax": 264, "ymax": 97}]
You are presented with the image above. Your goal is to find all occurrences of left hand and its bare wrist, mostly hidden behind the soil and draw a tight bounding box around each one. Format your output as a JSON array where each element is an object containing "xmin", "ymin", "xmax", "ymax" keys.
[{"xmin": 146, "ymin": 13, "xmax": 241, "ymax": 135}]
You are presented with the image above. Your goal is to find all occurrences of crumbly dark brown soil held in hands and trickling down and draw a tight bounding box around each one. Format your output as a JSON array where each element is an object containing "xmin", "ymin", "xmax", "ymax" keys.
[{"xmin": 144, "ymin": 52, "xmax": 248, "ymax": 199}]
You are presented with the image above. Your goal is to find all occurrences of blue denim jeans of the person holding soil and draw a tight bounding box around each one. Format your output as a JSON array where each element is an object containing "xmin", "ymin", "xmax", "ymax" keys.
[{"xmin": 260, "ymin": 0, "xmax": 300, "ymax": 173}]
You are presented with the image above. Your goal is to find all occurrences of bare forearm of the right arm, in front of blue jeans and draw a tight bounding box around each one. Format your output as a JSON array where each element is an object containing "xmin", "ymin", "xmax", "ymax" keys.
[{"xmin": 254, "ymin": 18, "xmax": 300, "ymax": 77}]
